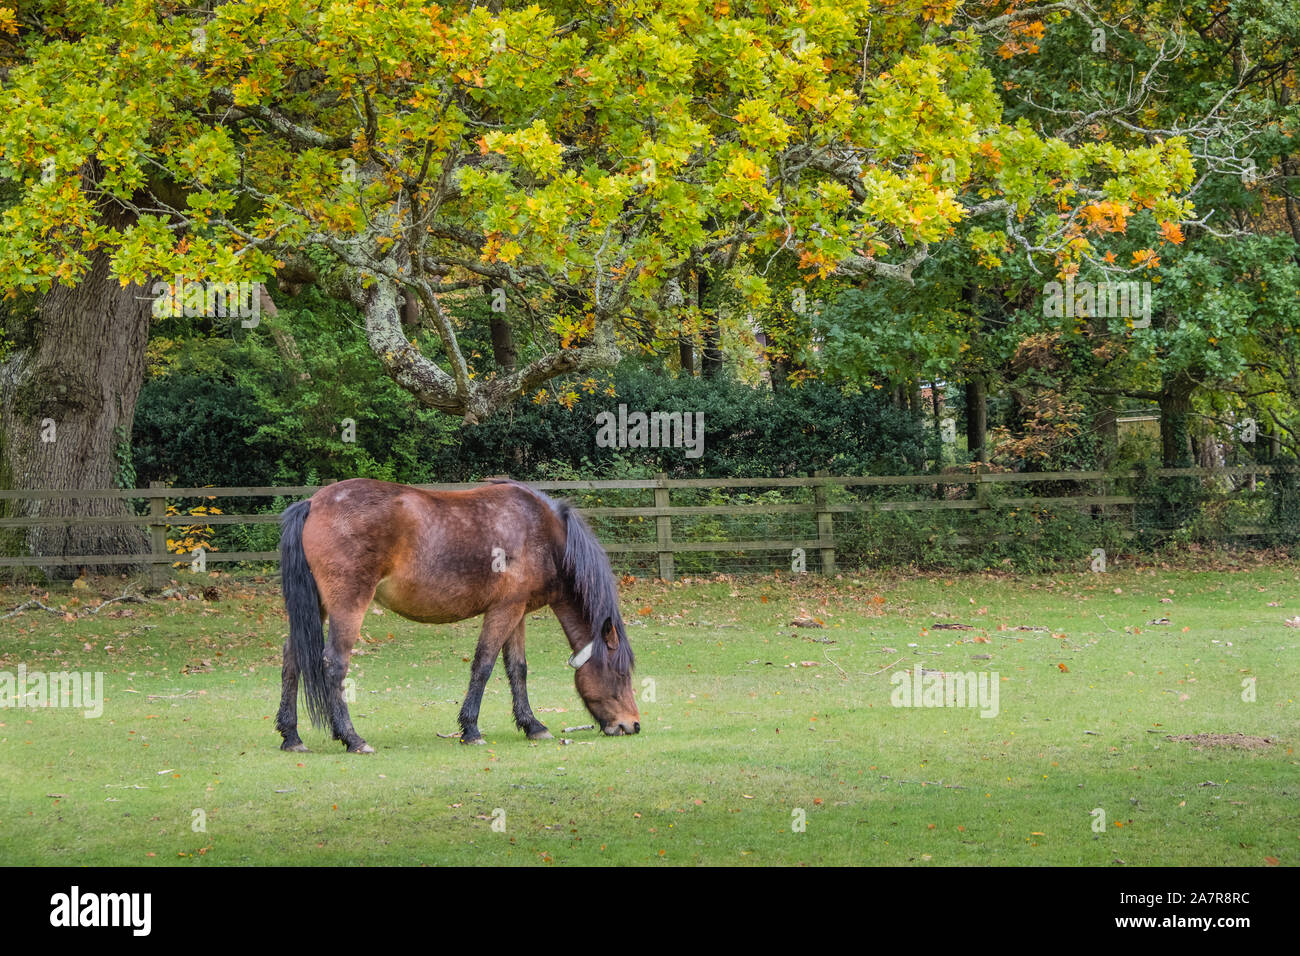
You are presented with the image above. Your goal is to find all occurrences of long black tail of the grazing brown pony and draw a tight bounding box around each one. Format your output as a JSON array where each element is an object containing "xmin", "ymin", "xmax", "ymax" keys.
[{"xmin": 280, "ymin": 501, "xmax": 329, "ymax": 727}]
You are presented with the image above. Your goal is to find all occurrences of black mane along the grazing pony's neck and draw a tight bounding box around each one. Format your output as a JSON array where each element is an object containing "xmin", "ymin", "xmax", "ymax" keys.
[{"xmin": 489, "ymin": 479, "xmax": 636, "ymax": 676}]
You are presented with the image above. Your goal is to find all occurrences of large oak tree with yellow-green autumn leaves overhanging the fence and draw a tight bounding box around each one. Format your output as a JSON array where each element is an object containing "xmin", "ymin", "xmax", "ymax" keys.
[{"xmin": 0, "ymin": 0, "xmax": 1191, "ymax": 572}]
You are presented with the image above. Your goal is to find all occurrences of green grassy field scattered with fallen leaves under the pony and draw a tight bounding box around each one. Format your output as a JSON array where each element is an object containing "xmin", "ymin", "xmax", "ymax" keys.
[{"xmin": 0, "ymin": 563, "xmax": 1300, "ymax": 866}]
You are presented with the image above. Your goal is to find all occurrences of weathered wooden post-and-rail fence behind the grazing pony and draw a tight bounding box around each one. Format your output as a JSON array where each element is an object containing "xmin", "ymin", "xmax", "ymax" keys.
[{"xmin": 0, "ymin": 464, "xmax": 1300, "ymax": 581}]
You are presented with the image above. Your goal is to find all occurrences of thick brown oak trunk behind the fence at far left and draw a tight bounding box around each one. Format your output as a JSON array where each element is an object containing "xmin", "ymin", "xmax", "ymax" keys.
[{"xmin": 0, "ymin": 191, "xmax": 152, "ymax": 576}]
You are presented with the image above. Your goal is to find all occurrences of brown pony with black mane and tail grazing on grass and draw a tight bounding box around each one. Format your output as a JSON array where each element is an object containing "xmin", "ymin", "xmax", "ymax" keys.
[{"xmin": 276, "ymin": 479, "xmax": 641, "ymax": 753}]
